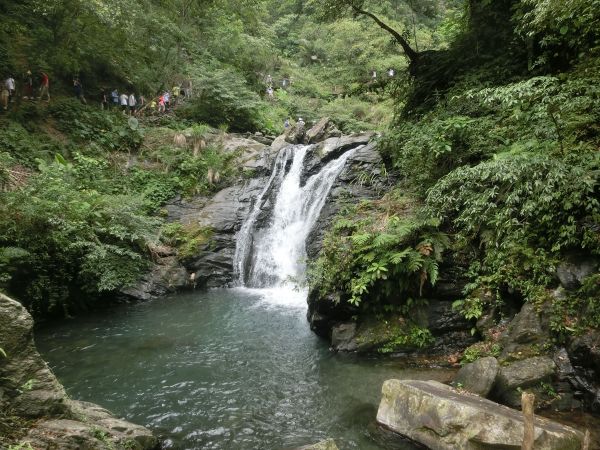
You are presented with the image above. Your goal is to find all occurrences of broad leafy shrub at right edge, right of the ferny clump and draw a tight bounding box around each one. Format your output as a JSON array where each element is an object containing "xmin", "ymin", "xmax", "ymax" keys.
[{"xmin": 427, "ymin": 153, "xmax": 600, "ymax": 306}]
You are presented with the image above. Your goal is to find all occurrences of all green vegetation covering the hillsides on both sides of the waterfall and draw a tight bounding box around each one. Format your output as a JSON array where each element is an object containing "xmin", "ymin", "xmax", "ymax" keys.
[{"xmin": 0, "ymin": 0, "xmax": 600, "ymax": 344}]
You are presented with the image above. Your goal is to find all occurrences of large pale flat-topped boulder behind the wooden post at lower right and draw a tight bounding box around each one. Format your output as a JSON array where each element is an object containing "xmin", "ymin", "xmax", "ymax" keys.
[{"xmin": 377, "ymin": 380, "xmax": 583, "ymax": 450}]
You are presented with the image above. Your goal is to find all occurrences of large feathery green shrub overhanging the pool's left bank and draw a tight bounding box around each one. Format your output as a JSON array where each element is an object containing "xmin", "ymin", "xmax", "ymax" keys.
[{"xmin": 0, "ymin": 160, "xmax": 158, "ymax": 315}]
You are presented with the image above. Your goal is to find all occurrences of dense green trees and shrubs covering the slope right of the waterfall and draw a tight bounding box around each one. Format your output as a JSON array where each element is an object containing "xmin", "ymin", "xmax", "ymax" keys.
[{"xmin": 311, "ymin": 0, "xmax": 600, "ymax": 344}]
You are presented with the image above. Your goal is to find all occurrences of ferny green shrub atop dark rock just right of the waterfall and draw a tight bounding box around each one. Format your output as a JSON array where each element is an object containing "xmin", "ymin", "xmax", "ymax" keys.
[{"xmin": 309, "ymin": 193, "xmax": 448, "ymax": 312}]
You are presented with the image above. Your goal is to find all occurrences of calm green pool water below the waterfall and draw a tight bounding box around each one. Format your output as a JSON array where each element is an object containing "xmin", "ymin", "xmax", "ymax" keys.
[{"xmin": 36, "ymin": 289, "xmax": 452, "ymax": 450}]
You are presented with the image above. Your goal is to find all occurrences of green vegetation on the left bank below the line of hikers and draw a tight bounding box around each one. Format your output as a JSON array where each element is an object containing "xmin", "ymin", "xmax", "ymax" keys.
[{"xmin": 0, "ymin": 99, "xmax": 235, "ymax": 316}]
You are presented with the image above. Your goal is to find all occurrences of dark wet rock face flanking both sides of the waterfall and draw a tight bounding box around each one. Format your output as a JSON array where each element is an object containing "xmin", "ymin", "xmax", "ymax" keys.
[{"xmin": 183, "ymin": 124, "xmax": 381, "ymax": 288}]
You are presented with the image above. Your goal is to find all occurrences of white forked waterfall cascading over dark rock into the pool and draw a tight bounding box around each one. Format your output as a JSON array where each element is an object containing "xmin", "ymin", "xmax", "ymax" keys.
[{"xmin": 234, "ymin": 145, "xmax": 353, "ymax": 288}]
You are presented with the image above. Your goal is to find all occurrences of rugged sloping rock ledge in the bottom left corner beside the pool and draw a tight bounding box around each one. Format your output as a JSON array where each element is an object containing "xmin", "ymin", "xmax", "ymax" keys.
[{"xmin": 0, "ymin": 294, "xmax": 159, "ymax": 450}]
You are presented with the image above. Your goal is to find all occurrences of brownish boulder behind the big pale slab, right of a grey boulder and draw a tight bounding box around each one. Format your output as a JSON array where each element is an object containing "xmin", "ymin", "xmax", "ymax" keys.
[{"xmin": 494, "ymin": 356, "xmax": 556, "ymax": 408}]
